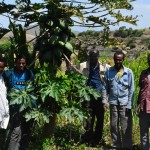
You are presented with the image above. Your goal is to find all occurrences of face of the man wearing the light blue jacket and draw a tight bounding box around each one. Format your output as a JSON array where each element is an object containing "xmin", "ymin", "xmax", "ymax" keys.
[{"xmin": 114, "ymin": 54, "xmax": 124, "ymax": 69}]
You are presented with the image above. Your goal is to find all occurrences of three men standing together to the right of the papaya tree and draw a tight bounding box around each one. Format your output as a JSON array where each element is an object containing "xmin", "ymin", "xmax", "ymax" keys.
[{"xmin": 77, "ymin": 50, "xmax": 150, "ymax": 150}]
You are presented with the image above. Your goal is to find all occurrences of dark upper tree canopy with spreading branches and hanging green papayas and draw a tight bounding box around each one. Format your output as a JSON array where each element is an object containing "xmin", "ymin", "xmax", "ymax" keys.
[{"xmin": 0, "ymin": 0, "xmax": 137, "ymax": 64}]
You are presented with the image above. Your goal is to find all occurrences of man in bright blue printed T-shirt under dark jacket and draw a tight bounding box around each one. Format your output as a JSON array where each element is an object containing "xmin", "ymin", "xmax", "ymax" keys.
[{"xmin": 3, "ymin": 55, "xmax": 34, "ymax": 150}]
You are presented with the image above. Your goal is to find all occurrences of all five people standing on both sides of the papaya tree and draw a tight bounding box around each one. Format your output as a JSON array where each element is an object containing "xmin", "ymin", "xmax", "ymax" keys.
[{"xmin": 0, "ymin": 50, "xmax": 150, "ymax": 150}]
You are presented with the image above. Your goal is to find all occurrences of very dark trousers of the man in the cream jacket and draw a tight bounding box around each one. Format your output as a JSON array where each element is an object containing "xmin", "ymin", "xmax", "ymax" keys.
[{"xmin": 83, "ymin": 96, "xmax": 104, "ymax": 142}]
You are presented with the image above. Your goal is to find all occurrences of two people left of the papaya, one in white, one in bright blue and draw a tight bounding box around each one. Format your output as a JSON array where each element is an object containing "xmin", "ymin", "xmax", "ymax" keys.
[{"xmin": 0, "ymin": 55, "xmax": 34, "ymax": 150}]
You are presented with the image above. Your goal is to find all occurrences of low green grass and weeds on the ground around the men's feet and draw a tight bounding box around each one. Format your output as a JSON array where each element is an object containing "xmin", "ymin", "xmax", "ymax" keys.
[{"xmin": 29, "ymin": 111, "xmax": 140, "ymax": 150}]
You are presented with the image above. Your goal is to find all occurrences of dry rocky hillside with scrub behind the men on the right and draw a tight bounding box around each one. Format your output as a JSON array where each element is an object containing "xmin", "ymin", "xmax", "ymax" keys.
[{"xmin": 73, "ymin": 27, "xmax": 150, "ymax": 51}]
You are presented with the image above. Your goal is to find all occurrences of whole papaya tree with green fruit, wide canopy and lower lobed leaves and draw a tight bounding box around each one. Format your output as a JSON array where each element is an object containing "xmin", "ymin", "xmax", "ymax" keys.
[{"xmin": 0, "ymin": 0, "xmax": 137, "ymax": 128}]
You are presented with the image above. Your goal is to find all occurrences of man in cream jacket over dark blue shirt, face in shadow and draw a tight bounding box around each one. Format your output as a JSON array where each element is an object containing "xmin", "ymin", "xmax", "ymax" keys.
[{"xmin": 77, "ymin": 50, "xmax": 109, "ymax": 146}]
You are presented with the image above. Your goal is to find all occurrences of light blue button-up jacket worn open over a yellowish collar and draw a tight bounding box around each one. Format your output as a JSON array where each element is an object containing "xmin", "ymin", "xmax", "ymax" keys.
[{"xmin": 104, "ymin": 66, "xmax": 134, "ymax": 109}]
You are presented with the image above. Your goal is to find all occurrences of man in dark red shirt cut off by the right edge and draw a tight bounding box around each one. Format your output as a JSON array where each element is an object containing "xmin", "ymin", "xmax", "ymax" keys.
[{"xmin": 136, "ymin": 54, "xmax": 150, "ymax": 150}]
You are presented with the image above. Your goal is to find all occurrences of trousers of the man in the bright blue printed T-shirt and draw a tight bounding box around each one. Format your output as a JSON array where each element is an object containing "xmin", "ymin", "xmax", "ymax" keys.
[{"xmin": 6, "ymin": 108, "xmax": 31, "ymax": 150}]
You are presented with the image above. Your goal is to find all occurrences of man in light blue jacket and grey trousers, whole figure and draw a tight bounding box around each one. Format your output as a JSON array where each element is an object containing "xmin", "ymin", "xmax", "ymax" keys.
[{"xmin": 104, "ymin": 51, "xmax": 134, "ymax": 149}]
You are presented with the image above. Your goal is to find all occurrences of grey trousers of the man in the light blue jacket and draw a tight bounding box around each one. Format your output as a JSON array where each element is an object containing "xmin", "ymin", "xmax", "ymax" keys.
[{"xmin": 110, "ymin": 104, "xmax": 132, "ymax": 150}]
